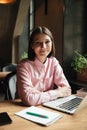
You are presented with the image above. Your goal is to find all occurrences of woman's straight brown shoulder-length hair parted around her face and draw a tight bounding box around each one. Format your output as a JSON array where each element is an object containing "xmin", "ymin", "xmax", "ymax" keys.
[{"xmin": 28, "ymin": 27, "xmax": 55, "ymax": 60}]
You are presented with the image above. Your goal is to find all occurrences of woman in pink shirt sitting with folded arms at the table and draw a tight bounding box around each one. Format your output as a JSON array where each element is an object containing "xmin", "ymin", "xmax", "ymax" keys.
[{"xmin": 17, "ymin": 27, "xmax": 71, "ymax": 106}]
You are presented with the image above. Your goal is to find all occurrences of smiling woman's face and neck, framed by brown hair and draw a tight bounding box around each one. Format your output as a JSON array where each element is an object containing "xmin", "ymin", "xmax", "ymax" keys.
[{"xmin": 32, "ymin": 33, "xmax": 52, "ymax": 63}]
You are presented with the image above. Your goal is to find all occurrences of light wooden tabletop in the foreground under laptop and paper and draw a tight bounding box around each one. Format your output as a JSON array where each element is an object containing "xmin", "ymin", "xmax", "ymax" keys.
[{"xmin": 0, "ymin": 98, "xmax": 87, "ymax": 130}]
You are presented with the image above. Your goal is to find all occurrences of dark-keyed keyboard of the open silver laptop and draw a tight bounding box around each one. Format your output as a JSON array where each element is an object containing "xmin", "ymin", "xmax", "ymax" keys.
[{"xmin": 56, "ymin": 97, "xmax": 82, "ymax": 111}]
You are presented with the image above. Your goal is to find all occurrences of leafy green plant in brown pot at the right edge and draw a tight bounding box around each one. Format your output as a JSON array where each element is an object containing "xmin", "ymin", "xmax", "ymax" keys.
[{"xmin": 71, "ymin": 51, "xmax": 87, "ymax": 82}]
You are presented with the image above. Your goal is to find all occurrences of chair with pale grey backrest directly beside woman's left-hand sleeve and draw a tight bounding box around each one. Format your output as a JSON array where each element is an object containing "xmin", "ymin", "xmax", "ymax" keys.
[{"xmin": 5, "ymin": 71, "xmax": 17, "ymax": 100}]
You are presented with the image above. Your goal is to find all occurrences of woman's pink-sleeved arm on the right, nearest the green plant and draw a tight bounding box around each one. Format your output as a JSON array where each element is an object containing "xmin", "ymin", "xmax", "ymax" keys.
[{"xmin": 53, "ymin": 58, "xmax": 71, "ymax": 97}]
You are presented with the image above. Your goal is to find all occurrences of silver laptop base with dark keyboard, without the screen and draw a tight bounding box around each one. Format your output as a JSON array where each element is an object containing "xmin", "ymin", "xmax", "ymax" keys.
[{"xmin": 42, "ymin": 95, "xmax": 83, "ymax": 114}]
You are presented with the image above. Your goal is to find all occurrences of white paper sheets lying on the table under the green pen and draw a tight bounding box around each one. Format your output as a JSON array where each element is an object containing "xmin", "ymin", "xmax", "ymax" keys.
[{"xmin": 15, "ymin": 106, "xmax": 62, "ymax": 126}]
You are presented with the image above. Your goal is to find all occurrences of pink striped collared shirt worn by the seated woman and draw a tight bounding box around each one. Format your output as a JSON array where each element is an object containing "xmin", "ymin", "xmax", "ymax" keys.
[{"xmin": 17, "ymin": 57, "xmax": 69, "ymax": 105}]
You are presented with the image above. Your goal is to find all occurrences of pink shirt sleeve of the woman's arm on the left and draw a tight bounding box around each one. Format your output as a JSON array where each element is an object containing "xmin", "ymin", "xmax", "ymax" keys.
[{"xmin": 17, "ymin": 60, "xmax": 58, "ymax": 106}]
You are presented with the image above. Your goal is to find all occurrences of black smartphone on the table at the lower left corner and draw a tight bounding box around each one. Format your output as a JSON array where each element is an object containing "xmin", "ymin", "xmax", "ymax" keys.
[{"xmin": 0, "ymin": 112, "xmax": 12, "ymax": 125}]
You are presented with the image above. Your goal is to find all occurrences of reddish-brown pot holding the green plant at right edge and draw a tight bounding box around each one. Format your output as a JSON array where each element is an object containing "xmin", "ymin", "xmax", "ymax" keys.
[{"xmin": 77, "ymin": 69, "xmax": 87, "ymax": 83}]
